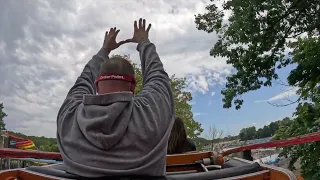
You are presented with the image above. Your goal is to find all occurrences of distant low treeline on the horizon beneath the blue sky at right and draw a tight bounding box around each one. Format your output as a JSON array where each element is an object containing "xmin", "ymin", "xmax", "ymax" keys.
[{"xmin": 239, "ymin": 117, "xmax": 291, "ymax": 141}]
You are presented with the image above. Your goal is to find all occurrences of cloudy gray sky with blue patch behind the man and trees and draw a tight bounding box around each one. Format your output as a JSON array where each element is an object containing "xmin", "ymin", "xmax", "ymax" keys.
[{"xmin": 0, "ymin": 0, "xmax": 296, "ymax": 137}]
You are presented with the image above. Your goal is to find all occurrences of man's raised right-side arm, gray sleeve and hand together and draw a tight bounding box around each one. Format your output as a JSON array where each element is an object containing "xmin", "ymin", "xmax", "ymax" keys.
[{"xmin": 127, "ymin": 19, "xmax": 175, "ymax": 115}]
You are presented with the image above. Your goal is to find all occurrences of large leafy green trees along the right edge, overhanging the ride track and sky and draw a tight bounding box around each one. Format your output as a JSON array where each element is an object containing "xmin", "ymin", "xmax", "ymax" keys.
[{"xmin": 195, "ymin": 0, "xmax": 320, "ymax": 179}]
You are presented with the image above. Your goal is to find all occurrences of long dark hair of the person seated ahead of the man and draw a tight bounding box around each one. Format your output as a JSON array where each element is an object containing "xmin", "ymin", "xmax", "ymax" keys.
[{"xmin": 167, "ymin": 117, "xmax": 187, "ymax": 154}]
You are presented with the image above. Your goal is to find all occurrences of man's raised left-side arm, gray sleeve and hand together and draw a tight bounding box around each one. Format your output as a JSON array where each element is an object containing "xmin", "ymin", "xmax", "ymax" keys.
[{"xmin": 58, "ymin": 28, "xmax": 125, "ymax": 124}]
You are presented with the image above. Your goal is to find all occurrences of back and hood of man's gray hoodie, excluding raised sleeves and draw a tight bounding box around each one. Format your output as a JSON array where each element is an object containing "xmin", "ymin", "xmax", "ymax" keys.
[{"xmin": 59, "ymin": 90, "xmax": 173, "ymax": 177}]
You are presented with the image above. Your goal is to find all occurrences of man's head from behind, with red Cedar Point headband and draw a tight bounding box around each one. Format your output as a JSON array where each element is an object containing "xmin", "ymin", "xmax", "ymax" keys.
[{"xmin": 96, "ymin": 57, "xmax": 136, "ymax": 94}]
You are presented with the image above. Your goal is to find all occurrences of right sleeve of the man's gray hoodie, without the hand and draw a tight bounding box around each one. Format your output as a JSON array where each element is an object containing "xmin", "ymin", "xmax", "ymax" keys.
[{"xmin": 136, "ymin": 40, "xmax": 175, "ymax": 119}]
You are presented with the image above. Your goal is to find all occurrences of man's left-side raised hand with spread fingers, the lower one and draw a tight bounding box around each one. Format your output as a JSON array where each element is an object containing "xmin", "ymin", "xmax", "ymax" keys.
[{"xmin": 103, "ymin": 27, "xmax": 128, "ymax": 53}]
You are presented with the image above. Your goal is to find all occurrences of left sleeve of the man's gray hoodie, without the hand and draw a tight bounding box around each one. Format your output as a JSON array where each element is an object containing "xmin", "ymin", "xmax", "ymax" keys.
[{"xmin": 58, "ymin": 49, "xmax": 109, "ymax": 125}]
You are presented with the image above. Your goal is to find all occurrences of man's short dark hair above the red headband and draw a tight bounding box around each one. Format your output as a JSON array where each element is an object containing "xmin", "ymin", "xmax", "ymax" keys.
[{"xmin": 99, "ymin": 56, "xmax": 134, "ymax": 77}]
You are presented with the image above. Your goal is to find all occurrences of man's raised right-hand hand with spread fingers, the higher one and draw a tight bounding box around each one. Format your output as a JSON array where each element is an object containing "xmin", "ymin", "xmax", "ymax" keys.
[{"xmin": 125, "ymin": 18, "xmax": 151, "ymax": 43}]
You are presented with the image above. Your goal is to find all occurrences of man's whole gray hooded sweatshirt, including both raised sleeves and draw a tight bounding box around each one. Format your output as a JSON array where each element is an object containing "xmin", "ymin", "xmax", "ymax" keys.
[{"xmin": 57, "ymin": 40, "xmax": 175, "ymax": 177}]
